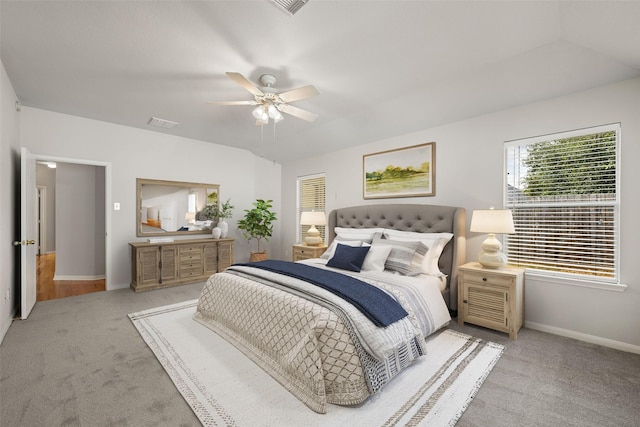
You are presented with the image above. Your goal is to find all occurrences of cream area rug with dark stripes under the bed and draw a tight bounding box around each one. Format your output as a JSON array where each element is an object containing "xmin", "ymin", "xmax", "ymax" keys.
[{"xmin": 129, "ymin": 300, "xmax": 504, "ymax": 427}]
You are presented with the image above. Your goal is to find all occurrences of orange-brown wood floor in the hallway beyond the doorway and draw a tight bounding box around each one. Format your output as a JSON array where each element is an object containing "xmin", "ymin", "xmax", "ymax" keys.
[{"xmin": 36, "ymin": 254, "xmax": 105, "ymax": 301}]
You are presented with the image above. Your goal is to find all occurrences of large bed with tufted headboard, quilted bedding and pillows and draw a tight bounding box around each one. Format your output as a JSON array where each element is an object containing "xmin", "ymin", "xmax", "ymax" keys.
[{"xmin": 194, "ymin": 204, "xmax": 466, "ymax": 413}]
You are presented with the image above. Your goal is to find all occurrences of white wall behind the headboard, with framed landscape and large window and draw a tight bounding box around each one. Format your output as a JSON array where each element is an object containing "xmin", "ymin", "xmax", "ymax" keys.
[{"xmin": 281, "ymin": 79, "xmax": 640, "ymax": 353}]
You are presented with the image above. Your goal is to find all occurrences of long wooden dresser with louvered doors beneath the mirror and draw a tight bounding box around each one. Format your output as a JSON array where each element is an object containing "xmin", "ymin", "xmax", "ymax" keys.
[{"xmin": 129, "ymin": 239, "xmax": 234, "ymax": 292}]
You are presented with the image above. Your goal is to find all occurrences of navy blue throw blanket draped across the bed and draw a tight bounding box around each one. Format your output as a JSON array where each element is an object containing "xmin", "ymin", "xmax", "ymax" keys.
[{"xmin": 235, "ymin": 260, "xmax": 408, "ymax": 327}]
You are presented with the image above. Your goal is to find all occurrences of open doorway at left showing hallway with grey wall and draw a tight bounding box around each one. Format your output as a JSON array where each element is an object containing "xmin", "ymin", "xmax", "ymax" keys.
[{"xmin": 36, "ymin": 161, "xmax": 106, "ymax": 301}]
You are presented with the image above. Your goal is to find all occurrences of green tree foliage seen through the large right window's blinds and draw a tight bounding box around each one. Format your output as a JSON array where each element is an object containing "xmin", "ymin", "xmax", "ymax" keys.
[{"xmin": 523, "ymin": 132, "xmax": 616, "ymax": 197}]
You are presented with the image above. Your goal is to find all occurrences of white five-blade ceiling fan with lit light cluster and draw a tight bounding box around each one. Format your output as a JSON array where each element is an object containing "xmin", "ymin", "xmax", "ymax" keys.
[{"xmin": 209, "ymin": 72, "xmax": 320, "ymax": 125}]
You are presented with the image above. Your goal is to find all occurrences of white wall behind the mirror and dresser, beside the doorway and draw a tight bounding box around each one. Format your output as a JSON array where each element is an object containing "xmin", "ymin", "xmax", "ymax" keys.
[{"xmin": 20, "ymin": 107, "xmax": 280, "ymax": 289}]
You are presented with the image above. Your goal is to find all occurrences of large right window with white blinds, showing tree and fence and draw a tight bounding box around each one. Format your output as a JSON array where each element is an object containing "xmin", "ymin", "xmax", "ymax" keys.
[{"xmin": 505, "ymin": 124, "xmax": 620, "ymax": 283}]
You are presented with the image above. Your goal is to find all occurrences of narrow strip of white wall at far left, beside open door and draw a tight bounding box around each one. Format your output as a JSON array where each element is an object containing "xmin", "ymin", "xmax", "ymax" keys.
[{"xmin": 0, "ymin": 62, "xmax": 20, "ymax": 343}]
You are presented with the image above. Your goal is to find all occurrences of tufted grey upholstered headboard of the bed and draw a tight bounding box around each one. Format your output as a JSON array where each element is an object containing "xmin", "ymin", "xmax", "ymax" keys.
[{"xmin": 327, "ymin": 204, "xmax": 467, "ymax": 312}]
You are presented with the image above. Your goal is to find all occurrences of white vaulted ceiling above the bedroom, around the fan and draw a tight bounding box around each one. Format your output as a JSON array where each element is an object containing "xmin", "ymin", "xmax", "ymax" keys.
[{"xmin": 0, "ymin": 0, "xmax": 640, "ymax": 163}]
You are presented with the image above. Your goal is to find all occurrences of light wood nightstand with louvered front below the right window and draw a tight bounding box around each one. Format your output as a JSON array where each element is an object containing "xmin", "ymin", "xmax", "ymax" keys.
[{"xmin": 458, "ymin": 262, "xmax": 524, "ymax": 340}]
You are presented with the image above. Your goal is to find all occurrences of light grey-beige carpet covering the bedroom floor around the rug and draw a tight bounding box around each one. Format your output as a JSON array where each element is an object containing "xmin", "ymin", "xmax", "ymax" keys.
[{"xmin": 0, "ymin": 283, "xmax": 640, "ymax": 427}]
